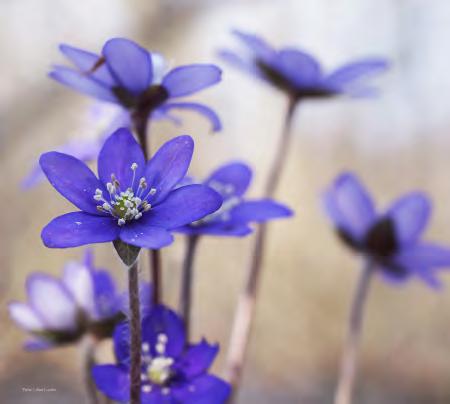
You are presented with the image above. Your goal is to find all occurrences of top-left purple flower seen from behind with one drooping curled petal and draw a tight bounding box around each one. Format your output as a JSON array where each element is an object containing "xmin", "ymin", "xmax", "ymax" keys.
[{"xmin": 50, "ymin": 38, "xmax": 222, "ymax": 131}]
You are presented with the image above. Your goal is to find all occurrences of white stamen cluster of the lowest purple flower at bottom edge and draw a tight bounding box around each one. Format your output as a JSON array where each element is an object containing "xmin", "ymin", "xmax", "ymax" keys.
[{"xmin": 141, "ymin": 334, "xmax": 174, "ymax": 395}]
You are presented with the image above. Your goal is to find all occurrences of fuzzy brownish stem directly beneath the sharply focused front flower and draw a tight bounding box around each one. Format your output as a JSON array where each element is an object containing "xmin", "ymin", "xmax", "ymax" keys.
[{"xmin": 128, "ymin": 260, "xmax": 141, "ymax": 404}]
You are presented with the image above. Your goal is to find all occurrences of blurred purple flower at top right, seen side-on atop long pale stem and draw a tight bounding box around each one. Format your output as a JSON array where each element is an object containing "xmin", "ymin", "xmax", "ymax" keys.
[{"xmin": 220, "ymin": 31, "xmax": 388, "ymax": 100}]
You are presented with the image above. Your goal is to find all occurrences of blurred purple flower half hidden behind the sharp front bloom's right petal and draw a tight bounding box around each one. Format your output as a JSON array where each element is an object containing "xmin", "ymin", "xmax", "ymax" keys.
[{"xmin": 177, "ymin": 163, "xmax": 292, "ymax": 237}]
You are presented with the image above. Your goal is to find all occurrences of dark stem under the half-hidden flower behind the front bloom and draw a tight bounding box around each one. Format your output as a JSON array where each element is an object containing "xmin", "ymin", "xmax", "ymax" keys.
[{"xmin": 180, "ymin": 236, "xmax": 199, "ymax": 341}]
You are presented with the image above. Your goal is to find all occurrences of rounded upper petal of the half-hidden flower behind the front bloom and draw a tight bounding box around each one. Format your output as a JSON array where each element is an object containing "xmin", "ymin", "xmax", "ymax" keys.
[{"xmin": 205, "ymin": 162, "xmax": 252, "ymax": 197}]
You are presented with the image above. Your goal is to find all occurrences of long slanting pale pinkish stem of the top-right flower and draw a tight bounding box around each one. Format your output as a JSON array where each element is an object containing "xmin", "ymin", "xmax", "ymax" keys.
[{"xmin": 225, "ymin": 98, "xmax": 298, "ymax": 402}]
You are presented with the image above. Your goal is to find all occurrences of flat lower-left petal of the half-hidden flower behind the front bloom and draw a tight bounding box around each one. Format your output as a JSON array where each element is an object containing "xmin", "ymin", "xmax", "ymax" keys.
[{"xmin": 175, "ymin": 220, "xmax": 253, "ymax": 237}]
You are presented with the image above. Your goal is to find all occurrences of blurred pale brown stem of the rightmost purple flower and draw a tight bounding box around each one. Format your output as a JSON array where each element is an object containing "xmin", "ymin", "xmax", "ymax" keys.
[{"xmin": 334, "ymin": 260, "xmax": 374, "ymax": 404}]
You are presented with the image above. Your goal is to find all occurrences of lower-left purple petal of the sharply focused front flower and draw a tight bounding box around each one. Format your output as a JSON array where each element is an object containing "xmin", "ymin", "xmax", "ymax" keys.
[{"xmin": 41, "ymin": 212, "xmax": 120, "ymax": 248}]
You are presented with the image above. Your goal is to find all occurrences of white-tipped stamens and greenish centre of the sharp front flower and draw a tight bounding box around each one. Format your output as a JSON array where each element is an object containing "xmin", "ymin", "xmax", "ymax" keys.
[{"xmin": 94, "ymin": 163, "xmax": 156, "ymax": 226}]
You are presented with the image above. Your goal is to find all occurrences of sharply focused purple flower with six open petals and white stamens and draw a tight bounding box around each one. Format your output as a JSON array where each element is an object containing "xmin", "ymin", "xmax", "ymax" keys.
[{"xmin": 40, "ymin": 129, "xmax": 222, "ymax": 249}]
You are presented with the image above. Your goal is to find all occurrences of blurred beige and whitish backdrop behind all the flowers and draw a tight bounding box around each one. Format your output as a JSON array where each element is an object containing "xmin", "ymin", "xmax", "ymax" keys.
[{"xmin": 0, "ymin": 0, "xmax": 450, "ymax": 404}]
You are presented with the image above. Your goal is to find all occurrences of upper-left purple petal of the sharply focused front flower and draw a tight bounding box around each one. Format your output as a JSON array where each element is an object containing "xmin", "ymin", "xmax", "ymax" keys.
[{"xmin": 39, "ymin": 152, "xmax": 106, "ymax": 214}]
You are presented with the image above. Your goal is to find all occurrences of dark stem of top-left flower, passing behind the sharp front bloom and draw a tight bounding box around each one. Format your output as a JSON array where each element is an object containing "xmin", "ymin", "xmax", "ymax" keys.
[{"xmin": 131, "ymin": 108, "xmax": 162, "ymax": 304}]
